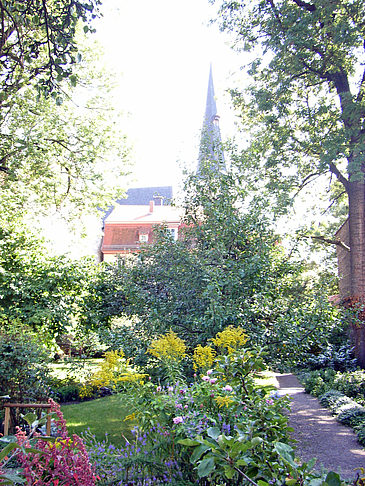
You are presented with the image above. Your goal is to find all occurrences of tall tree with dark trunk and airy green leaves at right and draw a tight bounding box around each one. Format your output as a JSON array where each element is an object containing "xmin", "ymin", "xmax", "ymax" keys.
[{"xmin": 212, "ymin": 0, "xmax": 365, "ymax": 367}]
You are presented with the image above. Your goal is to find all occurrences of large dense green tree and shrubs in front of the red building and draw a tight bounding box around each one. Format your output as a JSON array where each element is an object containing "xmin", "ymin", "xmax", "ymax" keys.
[{"xmin": 112, "ymin": 167, "xmax": 340, "ymax": 367}]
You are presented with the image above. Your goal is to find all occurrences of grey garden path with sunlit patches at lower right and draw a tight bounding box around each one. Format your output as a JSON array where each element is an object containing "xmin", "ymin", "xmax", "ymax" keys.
[{"xmin": 276, "ymin": 373, "xmax": 365, "ymax": 479}]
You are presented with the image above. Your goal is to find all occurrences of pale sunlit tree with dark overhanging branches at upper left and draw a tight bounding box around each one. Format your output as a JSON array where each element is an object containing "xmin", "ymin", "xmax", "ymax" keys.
[{"xmin": 0, "ymin": 0, "xmax": 128, "ymax": 216}]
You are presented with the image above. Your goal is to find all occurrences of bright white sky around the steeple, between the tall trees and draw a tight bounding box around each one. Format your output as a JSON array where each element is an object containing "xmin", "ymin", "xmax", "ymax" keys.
[{"xmin": 93, "ymin": 0, "xmax": 244, "ymax": 187}]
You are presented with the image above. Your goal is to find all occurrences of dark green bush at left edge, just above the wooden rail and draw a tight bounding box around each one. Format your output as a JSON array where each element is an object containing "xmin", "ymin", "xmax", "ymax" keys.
[{"xmin": 0, "ymin": 323, "xmax": 49, "ymax": 403}]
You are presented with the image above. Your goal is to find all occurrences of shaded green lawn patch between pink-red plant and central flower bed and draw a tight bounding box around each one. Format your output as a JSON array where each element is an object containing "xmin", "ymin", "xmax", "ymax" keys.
[{"xmin": 61, "ymin": 395, "xmax": 135, "ymax": 445}]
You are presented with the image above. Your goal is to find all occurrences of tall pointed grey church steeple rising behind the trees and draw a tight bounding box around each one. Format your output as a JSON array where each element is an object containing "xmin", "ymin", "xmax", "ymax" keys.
[{"xmin": 198, "ymin": 65, "xmax": 225, "ymax": 173}]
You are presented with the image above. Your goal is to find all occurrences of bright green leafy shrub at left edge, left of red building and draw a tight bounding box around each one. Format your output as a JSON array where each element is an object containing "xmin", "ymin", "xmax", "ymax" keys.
[{"xmin": 0, "ymin": 222, "xmax": 97, "ymax": 340}]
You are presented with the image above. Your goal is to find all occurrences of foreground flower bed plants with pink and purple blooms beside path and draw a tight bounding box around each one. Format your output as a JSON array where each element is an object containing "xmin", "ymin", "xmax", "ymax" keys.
[{"xmin": 85, "ymin": 329, "xmax": 350, "ymax": 486}]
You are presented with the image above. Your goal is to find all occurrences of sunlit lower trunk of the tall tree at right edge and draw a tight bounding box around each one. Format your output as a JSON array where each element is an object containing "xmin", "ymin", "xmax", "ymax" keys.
[{"xmin": 348, "ymin": 182, "xmax": 365, "ymax": 368}]
